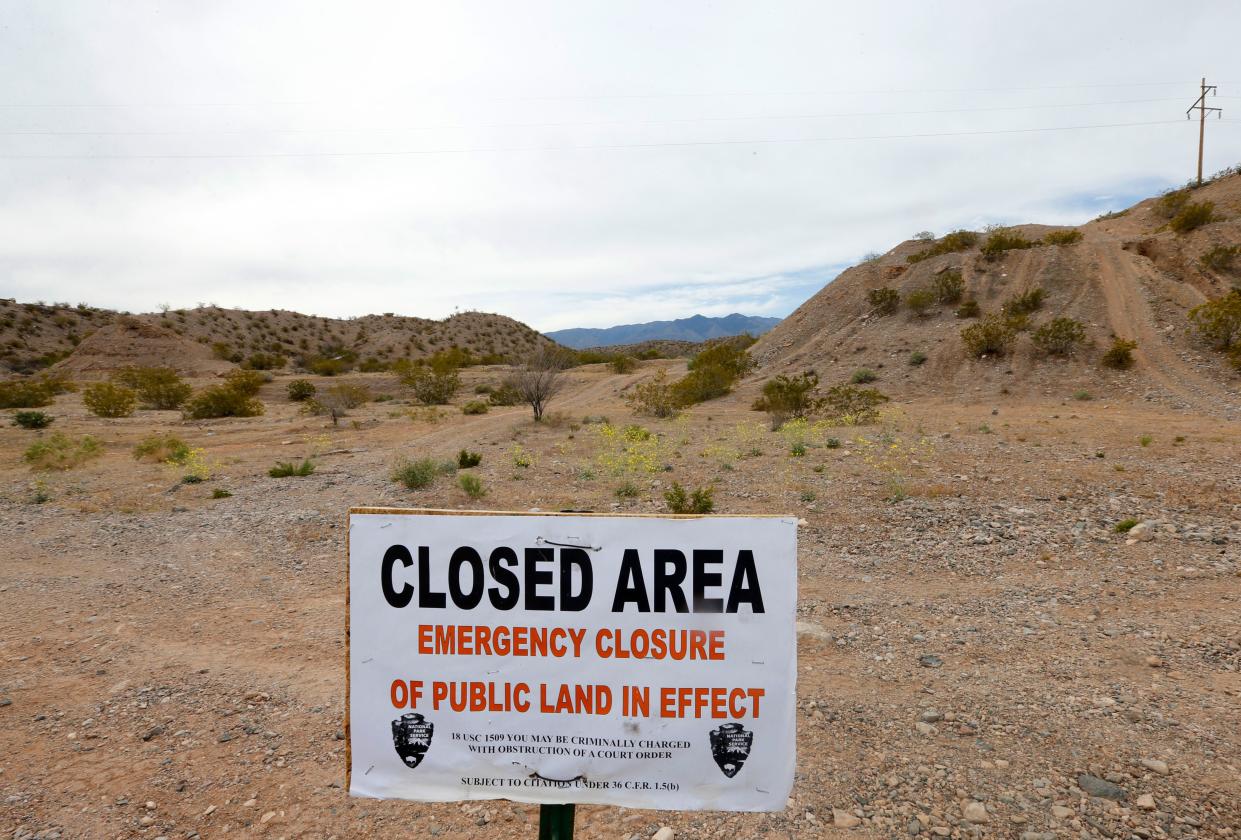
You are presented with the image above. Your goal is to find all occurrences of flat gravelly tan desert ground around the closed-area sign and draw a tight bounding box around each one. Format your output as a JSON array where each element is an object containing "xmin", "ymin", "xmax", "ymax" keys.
[{"xmin": 0, "ymin": 361, "xmax": 1241, "ymax": 840}]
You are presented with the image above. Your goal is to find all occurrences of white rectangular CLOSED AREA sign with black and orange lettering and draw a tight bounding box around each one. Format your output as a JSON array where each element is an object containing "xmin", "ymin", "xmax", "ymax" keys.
[{"xmin": 349, "ymin": 509, "xmax": 797, "ymax": 810}]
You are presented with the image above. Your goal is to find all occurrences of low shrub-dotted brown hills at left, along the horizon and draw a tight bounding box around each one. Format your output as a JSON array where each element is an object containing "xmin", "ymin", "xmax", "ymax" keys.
[{"xmin": 0, "ymin": 300, "xmax": 551, "ymax": 372}]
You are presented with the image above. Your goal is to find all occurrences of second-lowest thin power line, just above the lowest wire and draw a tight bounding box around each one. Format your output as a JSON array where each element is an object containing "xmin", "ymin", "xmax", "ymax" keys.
[{"xmin": 0, "ymin": 97, "xmax": 1178, "ymax": 136}]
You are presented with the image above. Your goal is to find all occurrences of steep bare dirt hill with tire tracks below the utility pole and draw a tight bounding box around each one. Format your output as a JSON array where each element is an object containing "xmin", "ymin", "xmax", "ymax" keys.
[{"xmin": 752, "ymin": 175, "xmax": 1241, "ymax": 411}]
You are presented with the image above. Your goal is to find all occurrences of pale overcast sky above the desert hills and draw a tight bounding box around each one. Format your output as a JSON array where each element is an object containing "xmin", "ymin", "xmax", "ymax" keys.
[{"xmin": 0, "ymin": 0, "xmax": 1241, "ymax": 330}]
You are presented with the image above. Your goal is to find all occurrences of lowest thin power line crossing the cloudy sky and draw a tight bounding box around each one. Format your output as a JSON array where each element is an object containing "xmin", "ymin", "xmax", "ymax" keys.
[{"xmin": 0, "ymin": 119, "xmax": 1183, "ymax": 160}]
